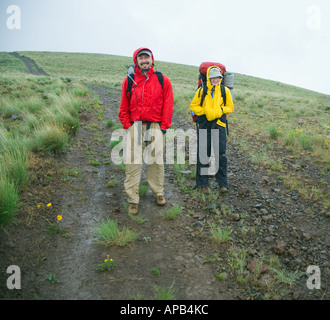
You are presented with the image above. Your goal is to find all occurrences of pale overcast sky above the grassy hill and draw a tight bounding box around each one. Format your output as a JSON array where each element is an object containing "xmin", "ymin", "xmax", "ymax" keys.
[{"xmin": 0, "ymin": 0, "xmax": 330, "ymax": 94}]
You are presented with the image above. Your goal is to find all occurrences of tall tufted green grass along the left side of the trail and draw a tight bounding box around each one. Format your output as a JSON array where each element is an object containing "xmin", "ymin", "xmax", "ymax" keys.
[{"xmin": 0, "ymin": 58, "xmax": 91, "ymax": 228}]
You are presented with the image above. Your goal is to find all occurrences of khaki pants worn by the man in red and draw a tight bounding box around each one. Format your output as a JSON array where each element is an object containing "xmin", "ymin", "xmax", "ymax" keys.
[{"xmin": 124, "ymin": 121, "xmax": 165, "ymax": 204}]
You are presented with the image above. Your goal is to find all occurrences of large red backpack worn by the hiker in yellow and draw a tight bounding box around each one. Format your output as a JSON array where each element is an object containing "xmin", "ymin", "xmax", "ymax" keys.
[{"xmin": 191, "ymin": 62, "xmax": 234, "ymax": 133}]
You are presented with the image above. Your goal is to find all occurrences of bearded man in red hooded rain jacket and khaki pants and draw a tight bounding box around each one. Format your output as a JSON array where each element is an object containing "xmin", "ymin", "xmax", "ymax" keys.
[{"xmin": 119, "ymin": 48, "xmax": 173, "ymax": 214}]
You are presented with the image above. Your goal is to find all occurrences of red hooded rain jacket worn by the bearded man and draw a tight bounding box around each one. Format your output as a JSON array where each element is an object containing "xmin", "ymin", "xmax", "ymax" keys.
[{"xmin": 119, "ymin": 48, "xmax": 173, "ymax": 129}]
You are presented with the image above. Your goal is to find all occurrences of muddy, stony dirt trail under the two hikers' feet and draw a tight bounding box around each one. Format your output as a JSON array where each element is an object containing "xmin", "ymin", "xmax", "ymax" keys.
[{"xmin": 0, "ymin": 57, "xmax": 329, "ymax": 300}]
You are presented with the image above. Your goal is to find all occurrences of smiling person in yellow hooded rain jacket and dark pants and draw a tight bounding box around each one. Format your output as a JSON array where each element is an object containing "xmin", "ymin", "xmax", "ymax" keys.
[{"xmin": 190, "ymin": 67, "xmax": 234, "ymax": 194}]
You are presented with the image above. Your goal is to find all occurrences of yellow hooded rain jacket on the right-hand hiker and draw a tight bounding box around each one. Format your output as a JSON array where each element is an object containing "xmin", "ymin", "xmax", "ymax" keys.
[{"xmin": 190, "ymin": 67, "xmax": 234, "ymax": 127}]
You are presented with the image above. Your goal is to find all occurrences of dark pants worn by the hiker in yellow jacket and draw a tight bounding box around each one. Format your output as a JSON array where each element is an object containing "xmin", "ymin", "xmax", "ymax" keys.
[{"xmin": 196, "ymin": 116, "xmax": 229, "ymax": 189}]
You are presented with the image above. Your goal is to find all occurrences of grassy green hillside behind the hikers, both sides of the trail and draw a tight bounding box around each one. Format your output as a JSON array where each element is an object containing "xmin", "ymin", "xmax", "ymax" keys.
[{"xmin": 0, "ymin": 52, "xmax": 330, "ymax": 223}]
